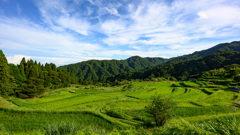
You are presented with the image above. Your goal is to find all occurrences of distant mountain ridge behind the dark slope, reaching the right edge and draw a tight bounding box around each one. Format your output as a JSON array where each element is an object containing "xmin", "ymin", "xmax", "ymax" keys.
[{"xmin": 60, "ymin": 41, "xmax": 240, "ymax": 81}]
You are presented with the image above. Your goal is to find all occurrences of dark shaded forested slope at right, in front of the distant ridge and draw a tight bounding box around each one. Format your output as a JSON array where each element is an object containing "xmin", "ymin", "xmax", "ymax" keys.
[{"xmin": 107, "ymin": 51, "xmax": 240, "ymax": 82}]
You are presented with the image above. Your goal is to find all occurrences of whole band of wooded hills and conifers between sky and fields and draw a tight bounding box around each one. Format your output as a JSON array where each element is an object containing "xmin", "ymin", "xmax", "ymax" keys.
[{"xmin": 0, "ymin": 41, "xmax": 240, "ymax": 98}]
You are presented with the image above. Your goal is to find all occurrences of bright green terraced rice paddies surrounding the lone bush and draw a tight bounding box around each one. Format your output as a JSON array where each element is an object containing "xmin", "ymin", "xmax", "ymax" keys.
[{"xmin": 0, "ymin": 82, "xmax": 240, "ymax": 134}]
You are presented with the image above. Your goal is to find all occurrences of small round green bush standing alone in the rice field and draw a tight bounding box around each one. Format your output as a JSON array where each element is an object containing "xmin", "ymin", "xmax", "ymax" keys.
[{"xmin": 145, "ymin": 95, "xmax": 176, "ymax": 126}]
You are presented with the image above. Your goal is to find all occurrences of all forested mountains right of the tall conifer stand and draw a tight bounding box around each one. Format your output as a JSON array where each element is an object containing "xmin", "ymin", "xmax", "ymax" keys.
[{"xmin": 60, "ymin": 41, "xmax": 240, "ymax": 84}]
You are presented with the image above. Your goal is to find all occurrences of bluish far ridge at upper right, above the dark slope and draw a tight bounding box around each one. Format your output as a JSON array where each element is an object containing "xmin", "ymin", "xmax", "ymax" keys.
[{"xmin": 166, "ymin": 41, "xmax": 240, "ymax": 63}]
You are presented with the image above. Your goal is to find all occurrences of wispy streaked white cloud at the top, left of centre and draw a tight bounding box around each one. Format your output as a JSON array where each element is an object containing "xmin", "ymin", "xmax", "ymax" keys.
[{"xmin": 37, "ymin": 0, "xmax": 91, "ymax": 35}]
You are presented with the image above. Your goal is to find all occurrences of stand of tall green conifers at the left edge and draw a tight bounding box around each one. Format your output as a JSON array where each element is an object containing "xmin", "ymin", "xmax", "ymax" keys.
[{"xmin": 0, "ymin": 50, "xmax": 78, "ymax": 98}]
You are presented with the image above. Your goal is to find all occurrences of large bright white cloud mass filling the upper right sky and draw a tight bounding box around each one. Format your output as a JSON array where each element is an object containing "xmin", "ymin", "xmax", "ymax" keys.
[{"xmin": 98, "ymin": 0, "xmax": 240, "ymax": 47}]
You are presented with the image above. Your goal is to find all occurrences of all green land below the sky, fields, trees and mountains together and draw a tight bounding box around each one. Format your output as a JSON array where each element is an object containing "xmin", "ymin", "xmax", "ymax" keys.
[{"xmin": 0, "ymin": 42, "xmax": 240, "ymax": 135}]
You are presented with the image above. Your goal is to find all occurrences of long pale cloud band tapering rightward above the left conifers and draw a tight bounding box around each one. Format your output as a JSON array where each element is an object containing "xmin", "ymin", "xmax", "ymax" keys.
[{"xmin": 0, "ymin": 18, "xmax": 101, "ymax": 56}]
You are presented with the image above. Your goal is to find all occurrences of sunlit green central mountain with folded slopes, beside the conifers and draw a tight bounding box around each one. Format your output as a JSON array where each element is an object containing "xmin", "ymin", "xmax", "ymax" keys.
[{"xmin": 60, "ymin": 56, "xmax": 167, "ymax": 81}]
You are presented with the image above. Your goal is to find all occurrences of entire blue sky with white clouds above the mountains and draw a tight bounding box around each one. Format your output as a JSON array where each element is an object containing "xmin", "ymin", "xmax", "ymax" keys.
[{"xmin": 0, "ymin": 0, "xmax": 240, "ymax": 66}]
